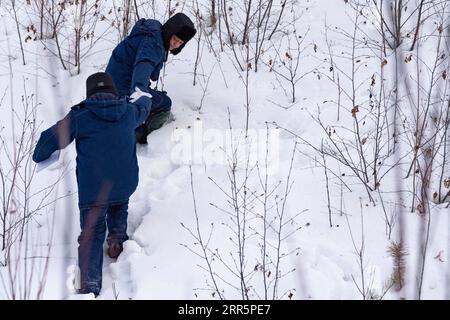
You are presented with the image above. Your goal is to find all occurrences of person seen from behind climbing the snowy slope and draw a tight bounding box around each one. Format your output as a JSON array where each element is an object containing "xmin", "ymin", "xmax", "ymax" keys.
[{"xmin": 33, "ymin": 72, "xmax": 150, "ymax": 296}]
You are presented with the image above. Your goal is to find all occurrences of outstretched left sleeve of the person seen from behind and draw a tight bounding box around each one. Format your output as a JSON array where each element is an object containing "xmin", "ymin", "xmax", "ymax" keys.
[{"xmin": 33, "ymin": 111, "xmax": 76, "ymax": 162}]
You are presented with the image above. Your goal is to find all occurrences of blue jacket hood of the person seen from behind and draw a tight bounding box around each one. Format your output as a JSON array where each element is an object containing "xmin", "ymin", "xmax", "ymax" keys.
[{"xmin": 83, "ymin": 93, "xmax": 128, "ymax": 122}]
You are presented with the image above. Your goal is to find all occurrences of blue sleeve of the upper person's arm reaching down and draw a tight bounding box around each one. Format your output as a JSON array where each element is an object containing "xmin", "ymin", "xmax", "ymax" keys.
[{"xmin": 130, "ymin": 36, "xmax": 160, "ymax": 92}]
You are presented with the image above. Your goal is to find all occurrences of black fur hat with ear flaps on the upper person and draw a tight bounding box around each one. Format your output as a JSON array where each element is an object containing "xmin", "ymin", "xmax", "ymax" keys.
[{"xmin": 161, "ymin": 12, "xmax": 197, "ymax": 55}]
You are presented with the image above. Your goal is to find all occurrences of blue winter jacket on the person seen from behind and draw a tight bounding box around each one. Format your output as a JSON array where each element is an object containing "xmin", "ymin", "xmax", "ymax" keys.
[{"xmin": 33, "ymin": 93, "xmax": 150, "ymax": 206}]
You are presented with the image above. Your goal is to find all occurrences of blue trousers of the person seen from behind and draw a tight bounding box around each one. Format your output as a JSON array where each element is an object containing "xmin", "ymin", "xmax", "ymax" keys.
[{"xmin": 78, "ymin": 199, "xmax": 128, "ymax": 295}]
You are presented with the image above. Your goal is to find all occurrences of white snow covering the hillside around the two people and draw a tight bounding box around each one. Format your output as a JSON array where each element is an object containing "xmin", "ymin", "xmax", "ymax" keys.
[{"xmin": 0, "ymin": 0, "xmax": 450, "ymax": 299}]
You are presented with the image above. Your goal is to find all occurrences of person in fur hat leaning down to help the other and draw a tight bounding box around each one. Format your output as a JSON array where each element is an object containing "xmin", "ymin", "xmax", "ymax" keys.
[{"xmin": 106, "ymin": 13, "xmax": 197, "ymax": 144}]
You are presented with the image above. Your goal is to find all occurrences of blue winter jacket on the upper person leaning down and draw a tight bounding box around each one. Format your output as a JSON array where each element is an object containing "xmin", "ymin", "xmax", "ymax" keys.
[{"xmin": 106, "ymin": 19, "xmax": 167, "ymax": 99}]
